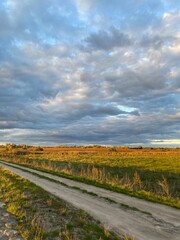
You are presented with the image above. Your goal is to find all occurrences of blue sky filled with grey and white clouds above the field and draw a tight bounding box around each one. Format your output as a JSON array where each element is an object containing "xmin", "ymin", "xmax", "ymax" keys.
[{"xmin": 0, "ymin": 0, "xmax": 180, "ymax": 147}]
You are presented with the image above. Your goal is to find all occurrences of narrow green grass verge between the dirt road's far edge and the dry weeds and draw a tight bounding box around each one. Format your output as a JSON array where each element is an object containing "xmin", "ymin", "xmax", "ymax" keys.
[{"xmin": 0, "ymin": 159, "xmax": 180, "ymax": 209}]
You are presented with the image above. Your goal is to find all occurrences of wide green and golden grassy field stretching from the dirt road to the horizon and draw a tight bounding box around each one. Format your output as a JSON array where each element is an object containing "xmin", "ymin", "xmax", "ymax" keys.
[{"xmin": 0, "ymin": 145, "xmax": 180, "ymax": 208}]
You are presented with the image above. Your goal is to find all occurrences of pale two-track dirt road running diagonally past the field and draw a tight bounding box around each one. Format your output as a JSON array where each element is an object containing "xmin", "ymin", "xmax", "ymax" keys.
[{"xmin": 0, "ymin": 161, "xmax": 180, "ymax": 240}]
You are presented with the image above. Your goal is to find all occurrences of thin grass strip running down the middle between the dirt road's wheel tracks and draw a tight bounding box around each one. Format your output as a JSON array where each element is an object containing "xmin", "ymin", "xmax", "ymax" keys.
[{"xmin": 0, "ymin": 160, "xmax": 151, "ymax": 215}]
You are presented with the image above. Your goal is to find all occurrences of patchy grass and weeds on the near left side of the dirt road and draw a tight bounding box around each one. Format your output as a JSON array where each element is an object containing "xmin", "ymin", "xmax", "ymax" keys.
[{"xmin": 0, "ymin": 168, "xmax": 130, "ymax": 240}]
